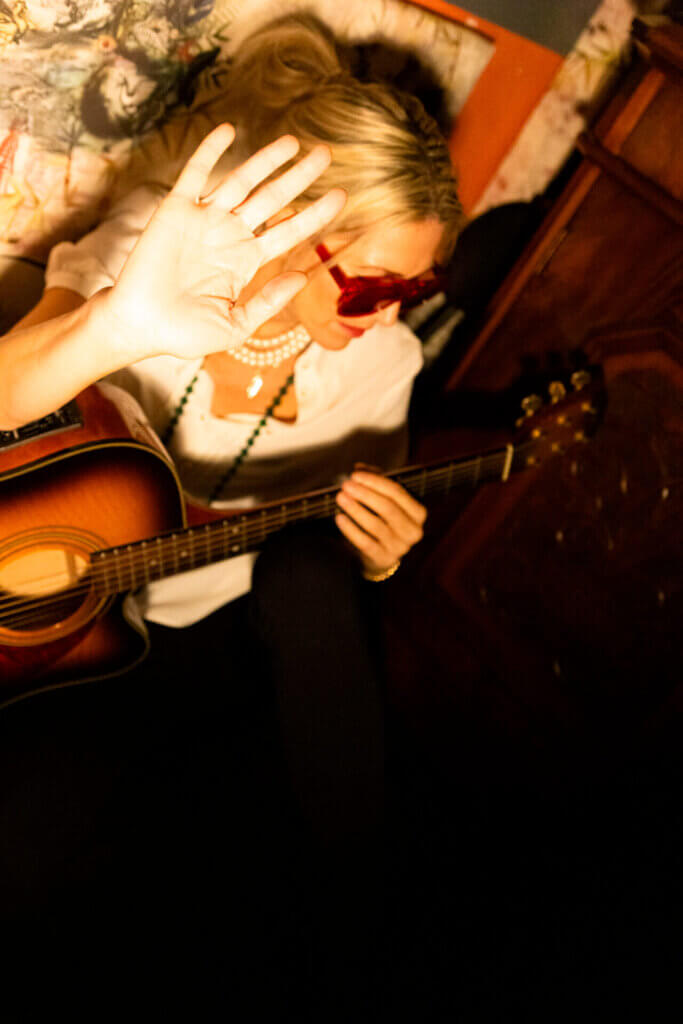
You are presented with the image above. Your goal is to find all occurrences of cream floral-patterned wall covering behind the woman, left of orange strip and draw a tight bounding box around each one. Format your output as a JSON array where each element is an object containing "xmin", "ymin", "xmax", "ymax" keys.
[{"xmin": 0, "ymin": 0, "xmax": 489, "ymax": 272}]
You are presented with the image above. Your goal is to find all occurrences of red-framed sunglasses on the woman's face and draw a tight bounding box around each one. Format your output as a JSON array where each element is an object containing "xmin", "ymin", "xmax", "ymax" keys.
[{"xmin": 315, "ymin": 244, "xmax": 445, "ymax": 316}]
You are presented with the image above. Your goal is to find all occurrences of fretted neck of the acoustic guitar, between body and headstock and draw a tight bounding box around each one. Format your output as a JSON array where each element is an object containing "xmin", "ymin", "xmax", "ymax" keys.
[{"xmin": 91, "ymin": 436, "xmax": 527, "ymax": 597}]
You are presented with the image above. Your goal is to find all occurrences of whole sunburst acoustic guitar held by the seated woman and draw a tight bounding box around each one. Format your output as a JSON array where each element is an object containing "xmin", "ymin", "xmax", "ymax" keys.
[{"xmin": 0, "ymin": 371, "xmax": 602, "ymax": 706}]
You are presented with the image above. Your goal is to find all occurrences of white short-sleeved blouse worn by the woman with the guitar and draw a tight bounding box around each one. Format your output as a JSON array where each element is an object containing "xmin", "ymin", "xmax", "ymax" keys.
[{"xmin": 45, "ymin": 185, "xmax": 422, "ymax": 627}]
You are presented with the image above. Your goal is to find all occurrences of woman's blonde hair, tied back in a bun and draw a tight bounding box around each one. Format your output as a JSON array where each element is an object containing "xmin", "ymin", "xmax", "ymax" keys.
[{"xmin": 219, "ymin": 14, "xmax": 463, "ymax": 261}]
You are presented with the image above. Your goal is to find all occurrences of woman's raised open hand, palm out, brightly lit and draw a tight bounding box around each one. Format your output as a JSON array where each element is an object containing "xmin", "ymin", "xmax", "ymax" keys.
[{"xmin": 105, "ymin": 124, "xmax": 346, "ymax": 361}]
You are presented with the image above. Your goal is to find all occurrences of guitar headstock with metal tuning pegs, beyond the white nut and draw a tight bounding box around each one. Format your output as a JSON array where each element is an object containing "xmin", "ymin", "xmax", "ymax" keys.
[{"xmin": 514, "ymin": 367, "xmax": 606, "ymax": 466}]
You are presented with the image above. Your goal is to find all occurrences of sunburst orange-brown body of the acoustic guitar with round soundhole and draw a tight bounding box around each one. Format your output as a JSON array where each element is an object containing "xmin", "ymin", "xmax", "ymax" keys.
[{"xmin": 0, "ymin": 385, "xmax": 185, "ymax": 703}]
